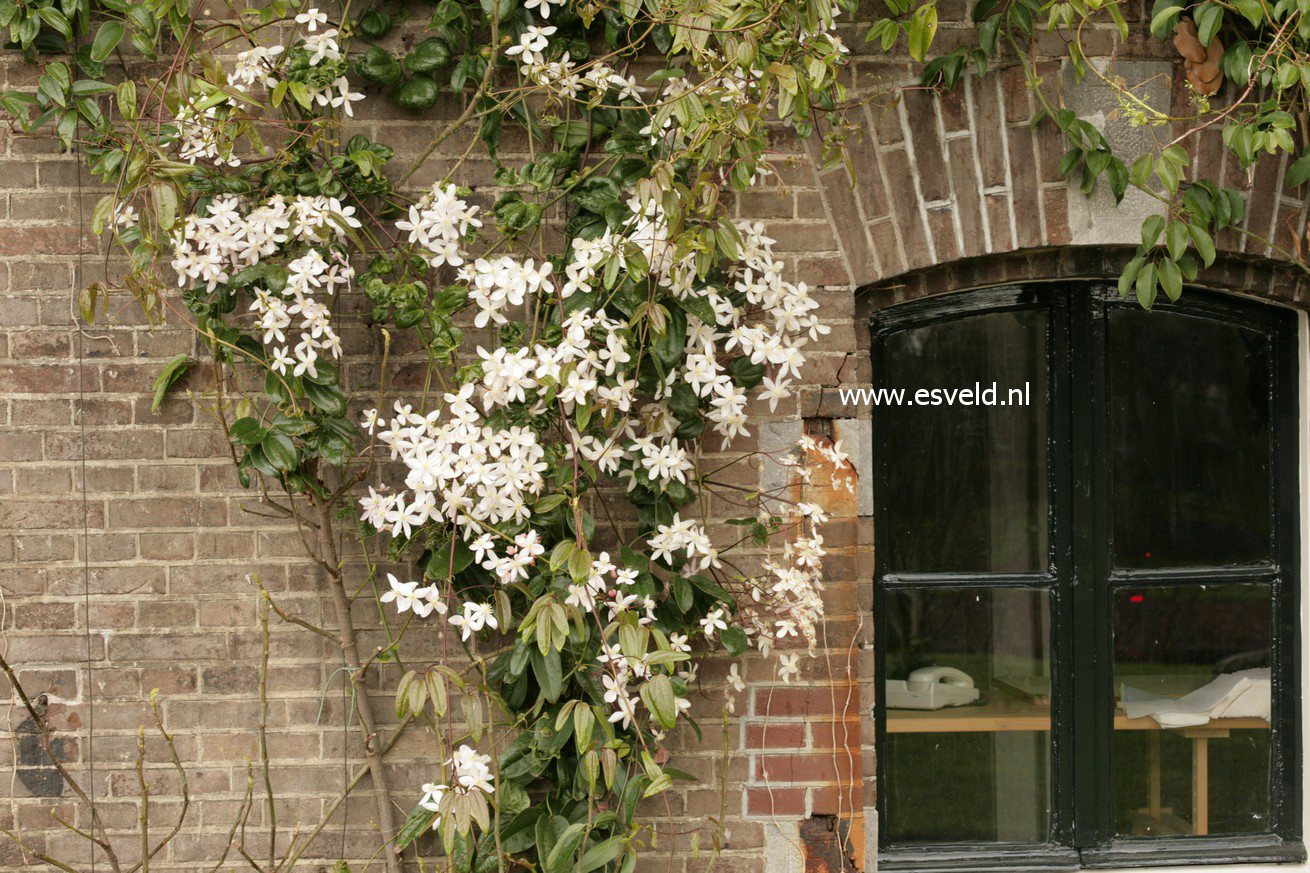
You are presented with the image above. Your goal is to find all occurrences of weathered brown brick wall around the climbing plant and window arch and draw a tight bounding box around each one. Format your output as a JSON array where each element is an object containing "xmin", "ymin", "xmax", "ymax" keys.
[{"xmin": 0, "ymin": 3, "xmax": 1306, "ymax": 873}]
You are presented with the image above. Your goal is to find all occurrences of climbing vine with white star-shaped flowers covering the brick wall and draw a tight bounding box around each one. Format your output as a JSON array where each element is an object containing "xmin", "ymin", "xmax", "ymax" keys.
[{"xmin": 0, "ymin": 0, "xmax": 850, "ymax": 873}]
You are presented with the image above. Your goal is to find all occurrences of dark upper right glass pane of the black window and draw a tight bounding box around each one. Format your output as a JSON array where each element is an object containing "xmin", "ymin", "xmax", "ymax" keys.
[{"xmin": 1110, "ymin": 308, "xmax": 1269, "ymax": 568}]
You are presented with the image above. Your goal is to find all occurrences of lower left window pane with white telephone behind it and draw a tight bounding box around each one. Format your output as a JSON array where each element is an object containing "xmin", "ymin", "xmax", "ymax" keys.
[{"xmin": 879, "ymin": 589, "xmax": 1051, "ymax": 844}]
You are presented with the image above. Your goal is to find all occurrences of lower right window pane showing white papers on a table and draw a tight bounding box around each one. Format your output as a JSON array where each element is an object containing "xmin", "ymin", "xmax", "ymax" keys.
[{"xmin": 1114, "ymin": 583, "xmax": 1272, "ymax": 836}]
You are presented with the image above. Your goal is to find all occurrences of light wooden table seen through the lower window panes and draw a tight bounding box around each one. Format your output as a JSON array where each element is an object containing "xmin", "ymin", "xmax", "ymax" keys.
[{"xmin": 887, "ymin": 691, "xmax": 1269, "ymax": 834}]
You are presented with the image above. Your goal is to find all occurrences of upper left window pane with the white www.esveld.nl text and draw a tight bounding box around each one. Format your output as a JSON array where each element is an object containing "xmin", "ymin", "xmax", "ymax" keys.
[{"xmin": 874, "ymin": 309, "xmax": 1047, "ymax": 572}]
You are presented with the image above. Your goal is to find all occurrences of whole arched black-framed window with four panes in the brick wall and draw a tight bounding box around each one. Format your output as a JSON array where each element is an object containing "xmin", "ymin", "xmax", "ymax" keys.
[{"xmin": 872, "ymin": 282, "xmax": 1305, "ymax": 870}]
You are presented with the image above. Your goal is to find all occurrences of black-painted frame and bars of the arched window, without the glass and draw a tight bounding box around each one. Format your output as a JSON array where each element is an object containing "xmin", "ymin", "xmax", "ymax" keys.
[{"xmin": 870, "ymin": 281, "xmax": 1306, "ymax": 873}]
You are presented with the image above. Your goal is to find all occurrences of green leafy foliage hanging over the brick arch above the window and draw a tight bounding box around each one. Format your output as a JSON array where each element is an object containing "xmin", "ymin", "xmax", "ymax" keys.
[{"xmin": 867, "ymin": 0, "xmax": 1310, "ymax": 308}]
